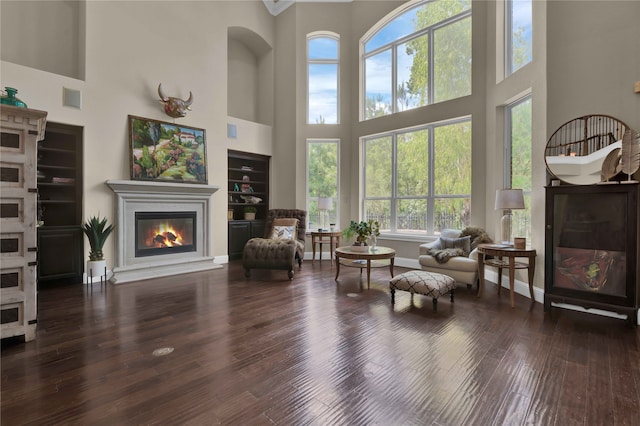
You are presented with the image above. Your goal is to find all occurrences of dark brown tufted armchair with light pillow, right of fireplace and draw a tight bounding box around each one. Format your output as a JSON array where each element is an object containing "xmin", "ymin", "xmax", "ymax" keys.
[{"xmin": 242, "ymin": 209, "xmax": 307, "ymax": 279}]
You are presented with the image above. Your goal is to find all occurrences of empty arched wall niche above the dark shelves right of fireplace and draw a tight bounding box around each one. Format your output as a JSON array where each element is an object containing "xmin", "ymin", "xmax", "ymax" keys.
[{"xmin": 227, "ymin": 27, "xmax": 274, "ymax": 126}]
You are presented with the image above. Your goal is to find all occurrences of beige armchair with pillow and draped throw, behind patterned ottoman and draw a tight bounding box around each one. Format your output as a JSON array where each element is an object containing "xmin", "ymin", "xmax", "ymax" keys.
[{"xmin": 418, "ymin": 228, "xmax": 492, "ymax": 287}]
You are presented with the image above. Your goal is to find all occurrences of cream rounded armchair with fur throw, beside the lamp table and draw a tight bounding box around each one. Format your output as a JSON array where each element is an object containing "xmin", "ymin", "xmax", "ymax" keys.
[{"xmin": 418, "ymin": 228, "xmax": 491, "ymax": 287}]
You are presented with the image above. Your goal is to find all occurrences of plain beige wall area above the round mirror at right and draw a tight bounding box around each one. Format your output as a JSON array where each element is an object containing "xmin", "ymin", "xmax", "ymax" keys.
[{"xmin": 547, "ymin": 0, "xmax": 640, "ymax": 131}]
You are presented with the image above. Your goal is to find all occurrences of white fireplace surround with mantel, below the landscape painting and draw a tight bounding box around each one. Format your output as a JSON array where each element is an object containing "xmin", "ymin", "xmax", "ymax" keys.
[{"xmin": 106, "ymin": 180, "xmax": 222, "ymax": 284}]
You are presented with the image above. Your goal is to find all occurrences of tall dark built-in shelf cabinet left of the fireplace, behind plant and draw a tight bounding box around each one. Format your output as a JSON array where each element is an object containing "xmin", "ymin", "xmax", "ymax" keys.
[{"xmin": 37, "ymin": 123, "xmax": 84, "ymax": 284}]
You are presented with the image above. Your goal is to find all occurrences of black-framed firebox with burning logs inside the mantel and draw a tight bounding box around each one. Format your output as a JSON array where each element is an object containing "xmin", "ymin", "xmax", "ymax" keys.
[{"xmin": 135, "ymin": 211, "xmax": 196, "ymax": 257}]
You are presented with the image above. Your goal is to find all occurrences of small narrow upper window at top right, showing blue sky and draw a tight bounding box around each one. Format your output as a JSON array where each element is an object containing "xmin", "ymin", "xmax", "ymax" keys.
[{"xmin": 505, "ymin": 0, "xmax": 533, "ymax": 75}]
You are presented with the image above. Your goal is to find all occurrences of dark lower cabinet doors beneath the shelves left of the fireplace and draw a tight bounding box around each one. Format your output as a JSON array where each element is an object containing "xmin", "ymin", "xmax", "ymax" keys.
[{"xmin": 38, "ymin": 226, "xmax": 83, "ymax": 285}]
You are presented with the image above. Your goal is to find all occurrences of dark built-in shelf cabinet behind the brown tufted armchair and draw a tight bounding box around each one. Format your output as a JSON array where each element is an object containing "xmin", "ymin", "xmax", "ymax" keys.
[{"xmin": 227, "ymin": 150, "xmax": 270, "ymax": 260}]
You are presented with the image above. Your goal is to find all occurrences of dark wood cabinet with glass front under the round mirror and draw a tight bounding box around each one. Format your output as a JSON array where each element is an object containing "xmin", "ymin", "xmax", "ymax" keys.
[{"xmin": 544, "ymin": 183, "xmax": 640, "ymax": 325}]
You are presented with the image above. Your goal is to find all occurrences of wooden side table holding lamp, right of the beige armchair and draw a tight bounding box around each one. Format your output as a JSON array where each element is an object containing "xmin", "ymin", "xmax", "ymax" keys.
[{"xmin": 478, "ymin": 244, "xmax": 536, "ymax": 308}]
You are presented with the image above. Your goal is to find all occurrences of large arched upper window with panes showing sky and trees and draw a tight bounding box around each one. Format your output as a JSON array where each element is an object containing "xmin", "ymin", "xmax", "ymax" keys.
[{"xmin": 362, "ymin": 0, "xmax": 471, "ymax": 120}]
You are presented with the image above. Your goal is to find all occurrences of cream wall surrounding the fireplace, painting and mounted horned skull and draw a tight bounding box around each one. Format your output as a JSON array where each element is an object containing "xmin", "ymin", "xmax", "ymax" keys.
[{"xmin": 0, "ymin": 1, "xmax": 274, "ymax": 267}]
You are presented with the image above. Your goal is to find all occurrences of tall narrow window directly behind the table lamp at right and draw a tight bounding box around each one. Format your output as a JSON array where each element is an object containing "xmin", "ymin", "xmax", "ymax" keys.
[{"xmin": 504, "ymin": 95, "xmax": 531, "ymax": 240}]
